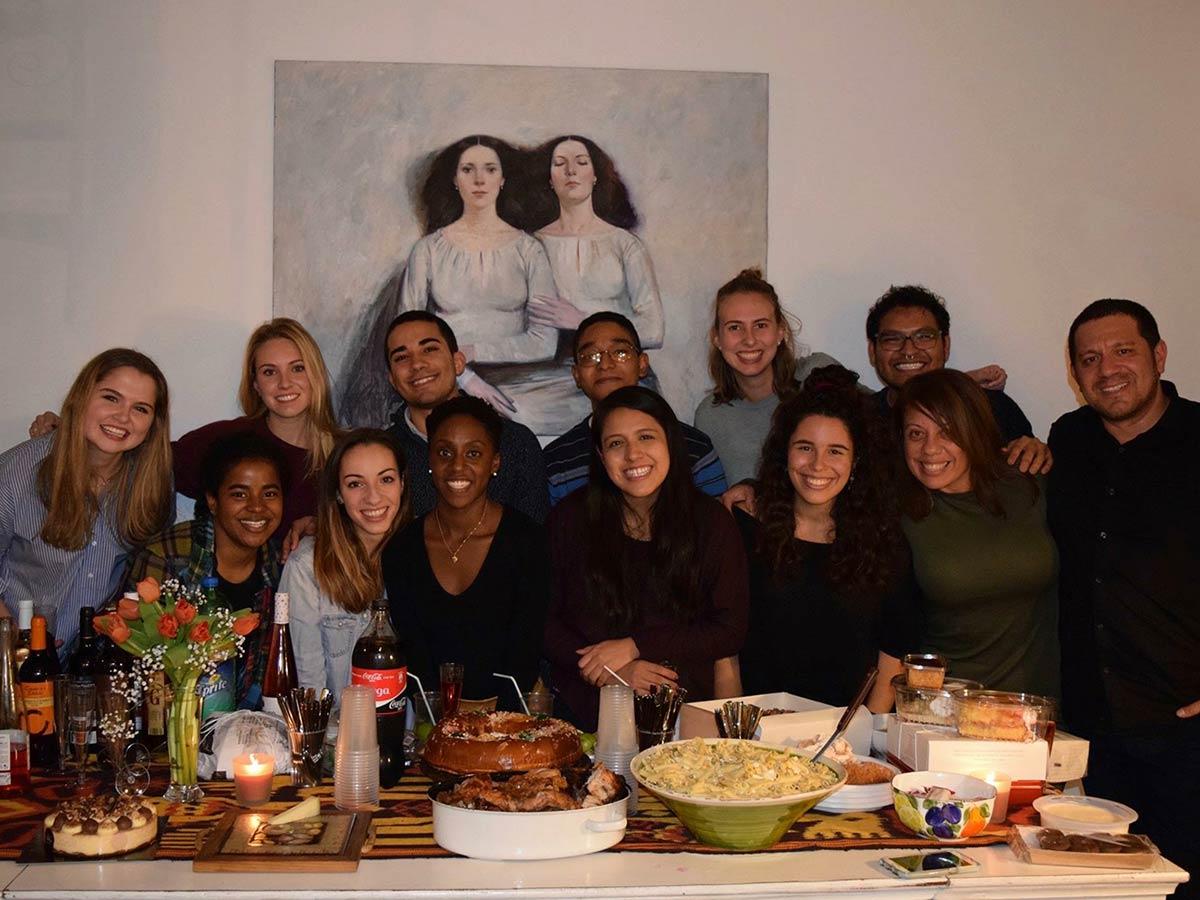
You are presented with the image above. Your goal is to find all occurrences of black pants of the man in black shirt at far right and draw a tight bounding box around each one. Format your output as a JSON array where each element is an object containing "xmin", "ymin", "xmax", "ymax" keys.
[{"xmin": 1084, "ymin": 718, "xmax": 1200, "ymax": 898}]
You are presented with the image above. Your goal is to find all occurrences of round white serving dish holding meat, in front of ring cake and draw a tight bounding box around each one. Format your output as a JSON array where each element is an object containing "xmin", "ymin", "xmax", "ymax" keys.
[{"xmin": 428, "ymin": 785, "xmax": 629, "ymax": 859}]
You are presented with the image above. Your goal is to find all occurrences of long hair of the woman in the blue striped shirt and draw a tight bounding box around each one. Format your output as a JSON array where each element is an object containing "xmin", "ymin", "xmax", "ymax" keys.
[{"xmin": 37, "ymin": 347, "xmax": 174, "ymax": 550}]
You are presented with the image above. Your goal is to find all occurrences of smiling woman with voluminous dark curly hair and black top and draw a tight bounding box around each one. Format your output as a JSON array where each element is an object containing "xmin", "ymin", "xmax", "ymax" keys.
[{"xmin": 734, "ymin": 366, "xmax": 919, "ymax": 712}]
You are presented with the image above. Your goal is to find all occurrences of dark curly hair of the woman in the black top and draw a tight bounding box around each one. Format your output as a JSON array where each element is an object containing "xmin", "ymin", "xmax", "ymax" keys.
[{"xmin": 757, "ymin": 366, "xmax": 906, "ymax": 594}]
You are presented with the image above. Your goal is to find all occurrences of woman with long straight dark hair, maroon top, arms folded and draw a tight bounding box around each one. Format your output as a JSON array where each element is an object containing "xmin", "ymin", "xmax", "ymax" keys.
[{"xmin": 544, "ymin": 386, "xmax": 748, "ymax": 731}]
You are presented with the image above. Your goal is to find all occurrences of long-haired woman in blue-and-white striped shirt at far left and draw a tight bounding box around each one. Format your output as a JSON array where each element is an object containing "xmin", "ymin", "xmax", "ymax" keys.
[{"xmin": 0, "ymin": 348, "xmax": 173, "ymax": 653}]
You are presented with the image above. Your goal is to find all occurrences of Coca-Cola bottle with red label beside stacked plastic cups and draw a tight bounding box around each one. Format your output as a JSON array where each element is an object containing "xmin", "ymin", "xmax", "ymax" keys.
[{"xmin": 350, "ymin": 598, "xmax": 408, "ymax": 787}]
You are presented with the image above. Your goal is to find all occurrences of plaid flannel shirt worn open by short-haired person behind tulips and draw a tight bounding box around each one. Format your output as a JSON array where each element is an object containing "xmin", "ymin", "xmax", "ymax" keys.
[{"xmin": 127, "ymin": 518, "xmax": 280, "ymax": 709}]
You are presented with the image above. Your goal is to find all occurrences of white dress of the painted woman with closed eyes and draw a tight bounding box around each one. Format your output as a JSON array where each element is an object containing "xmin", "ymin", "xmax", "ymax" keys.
[{"xmin": 536, "ymin": 226, "xmax": 664, "ymax": 432}]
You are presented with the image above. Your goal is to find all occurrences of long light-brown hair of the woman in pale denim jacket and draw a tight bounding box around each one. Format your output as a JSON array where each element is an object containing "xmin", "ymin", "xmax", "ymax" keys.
[{"xmin": 312, "ymin": 428, "xmax": 412, "ymax": 612}]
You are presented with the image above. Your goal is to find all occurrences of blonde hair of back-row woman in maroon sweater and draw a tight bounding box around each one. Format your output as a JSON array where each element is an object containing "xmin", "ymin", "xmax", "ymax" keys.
[{"xmin": 238, "ymin": 318, "xmax": 341, "ymax": 475}]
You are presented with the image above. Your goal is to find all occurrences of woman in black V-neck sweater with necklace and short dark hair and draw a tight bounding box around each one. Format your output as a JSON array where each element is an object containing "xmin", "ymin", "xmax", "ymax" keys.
[{"xmin": 383, "ymin": 396, "xmax": 550, "ymax": 709}]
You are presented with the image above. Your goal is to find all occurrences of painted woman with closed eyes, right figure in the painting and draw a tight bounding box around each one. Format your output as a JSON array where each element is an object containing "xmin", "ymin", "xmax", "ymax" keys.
[{"xmin": 529, "ymin": 134, "xmax": 664, "ymax": 426}]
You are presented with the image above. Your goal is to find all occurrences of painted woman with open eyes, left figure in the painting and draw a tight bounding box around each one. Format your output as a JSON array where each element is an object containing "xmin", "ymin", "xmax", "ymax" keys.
[{"xmin": 400, "ymin": 134, "xmax": 558, "ymax": 433}]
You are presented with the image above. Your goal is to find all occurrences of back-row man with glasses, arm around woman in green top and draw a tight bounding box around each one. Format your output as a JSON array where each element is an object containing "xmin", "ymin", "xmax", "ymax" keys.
[{"xmin": 866, "ymin": 284, "xmax": 1051, "ymax": 474}]
